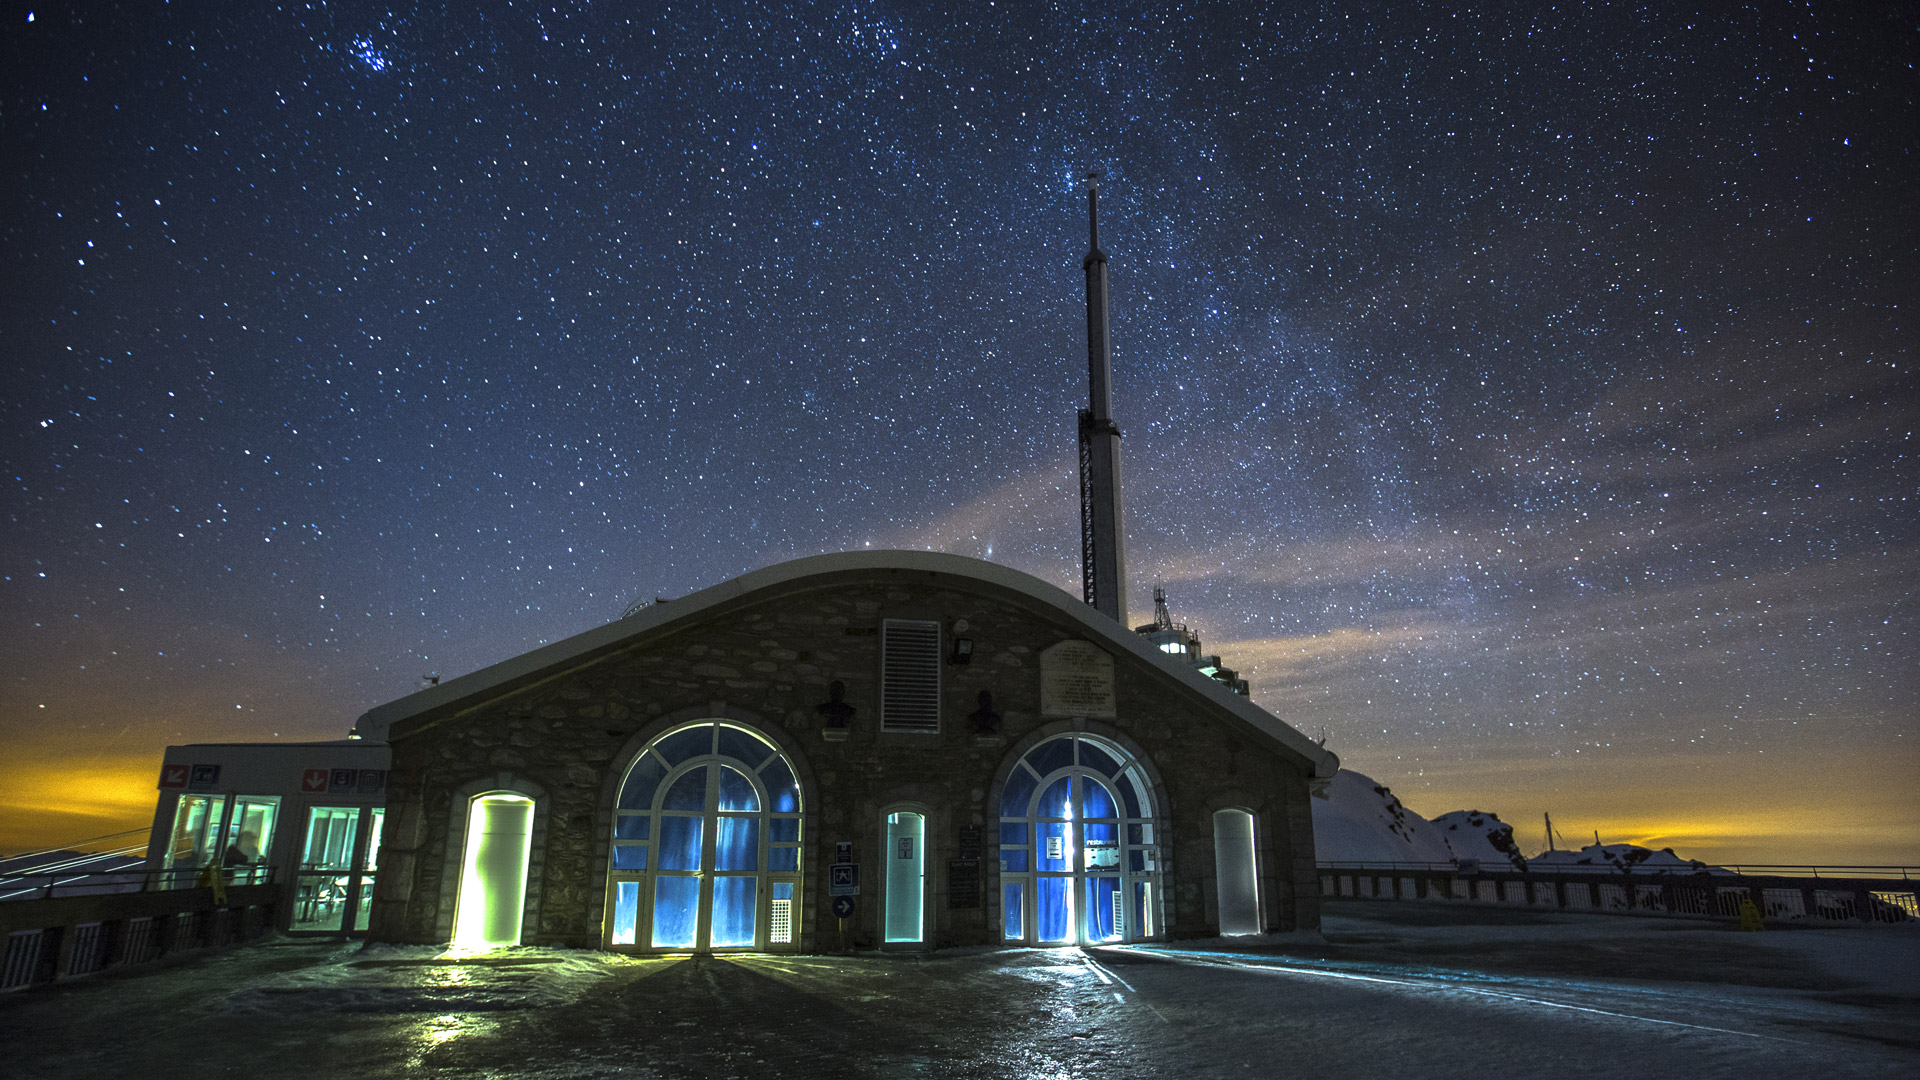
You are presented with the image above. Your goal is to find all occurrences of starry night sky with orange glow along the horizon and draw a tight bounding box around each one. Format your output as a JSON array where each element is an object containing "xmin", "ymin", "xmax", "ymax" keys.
[{"xmin": 0, "ymin": 0, "xmax": 1920, "ymax": 863}]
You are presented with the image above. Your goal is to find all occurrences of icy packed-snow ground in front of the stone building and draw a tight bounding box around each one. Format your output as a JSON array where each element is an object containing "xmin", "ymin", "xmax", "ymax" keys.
[{"xmin": 0, "ymin": 903, "xmax": 1920, "ymax": 1080}]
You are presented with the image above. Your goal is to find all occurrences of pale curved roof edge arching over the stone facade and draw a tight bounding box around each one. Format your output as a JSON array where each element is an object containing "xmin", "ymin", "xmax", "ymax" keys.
[{"xmin": 355, "ymin": 552, "xmax": 1340, "ymax": 776}]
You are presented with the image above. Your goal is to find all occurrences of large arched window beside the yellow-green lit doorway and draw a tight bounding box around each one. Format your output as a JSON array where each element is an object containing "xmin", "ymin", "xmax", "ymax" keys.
[{"xmin": 607, "ymin": 721, "xmax": 801, "ymax": 949}]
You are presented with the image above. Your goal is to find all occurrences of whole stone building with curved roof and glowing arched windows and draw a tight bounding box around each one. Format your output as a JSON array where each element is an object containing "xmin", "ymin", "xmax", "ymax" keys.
[{"xmin": 359, "ymin": 552, "xmax": 1338, "ymax": 951}]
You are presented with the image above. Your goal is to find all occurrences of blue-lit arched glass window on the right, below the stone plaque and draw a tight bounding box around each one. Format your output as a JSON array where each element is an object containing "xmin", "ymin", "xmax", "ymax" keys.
[{"xmin": 1000, "ymin": 734, "xmax": 1160, "ymax": 945}]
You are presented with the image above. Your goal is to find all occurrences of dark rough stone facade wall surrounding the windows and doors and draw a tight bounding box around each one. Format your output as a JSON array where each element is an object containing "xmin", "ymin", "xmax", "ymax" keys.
[{"xmin": 372, "ymin": 571, "xmax": 1319, "ymax": 951}]
